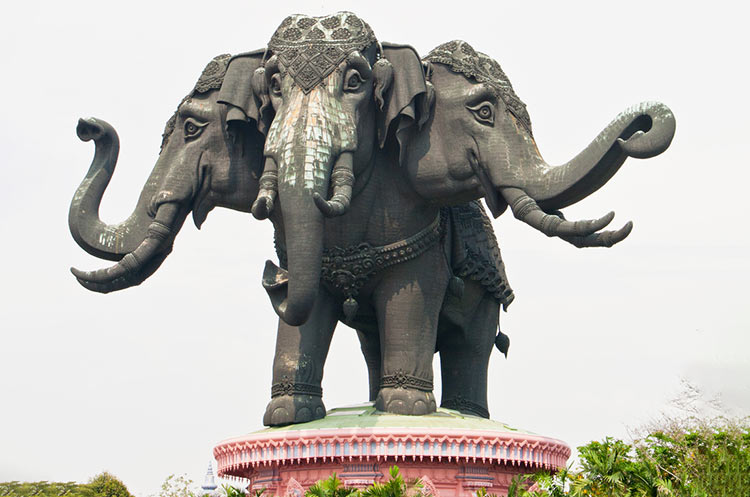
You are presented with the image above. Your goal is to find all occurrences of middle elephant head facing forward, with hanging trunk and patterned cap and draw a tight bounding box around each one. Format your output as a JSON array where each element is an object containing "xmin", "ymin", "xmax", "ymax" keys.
[{"xmin": 252, "ymin": 12, "xmax": 426, "ymax": 326}]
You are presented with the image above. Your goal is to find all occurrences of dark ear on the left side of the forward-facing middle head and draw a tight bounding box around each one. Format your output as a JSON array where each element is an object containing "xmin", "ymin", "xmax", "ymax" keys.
[{"xmin": 217, "ymin": 50, "xmax": 268, "ymax": 177}]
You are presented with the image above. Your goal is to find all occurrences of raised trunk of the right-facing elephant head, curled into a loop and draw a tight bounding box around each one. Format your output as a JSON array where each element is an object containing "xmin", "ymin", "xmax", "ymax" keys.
[{"xmin": 511, "ymin": 102, "xmax": 675, "ymax": 212}]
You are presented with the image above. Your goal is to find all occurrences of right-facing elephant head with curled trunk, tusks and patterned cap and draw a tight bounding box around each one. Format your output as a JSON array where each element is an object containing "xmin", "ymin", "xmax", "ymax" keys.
[{"xmin": 405, "ymin": 41, "xmax": 675, "ymax": 247}]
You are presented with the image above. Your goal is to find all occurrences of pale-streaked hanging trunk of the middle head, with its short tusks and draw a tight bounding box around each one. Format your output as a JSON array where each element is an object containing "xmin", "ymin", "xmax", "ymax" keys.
[{"xmin": 262, "ymin": 75, "xmax": 357, "ymax": 326}]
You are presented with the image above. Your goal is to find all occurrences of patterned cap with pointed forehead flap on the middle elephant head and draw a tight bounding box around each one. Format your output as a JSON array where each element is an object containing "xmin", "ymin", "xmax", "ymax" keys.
[{"xmin": 268, "ymin": 12, "xmax": 377, "ymax": 93}]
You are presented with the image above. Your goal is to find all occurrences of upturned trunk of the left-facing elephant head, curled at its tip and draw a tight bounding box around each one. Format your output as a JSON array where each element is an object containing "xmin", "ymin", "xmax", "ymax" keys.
[{"xmin": 68, "ymin": 118, "xmax": 172, "ymax": 261}]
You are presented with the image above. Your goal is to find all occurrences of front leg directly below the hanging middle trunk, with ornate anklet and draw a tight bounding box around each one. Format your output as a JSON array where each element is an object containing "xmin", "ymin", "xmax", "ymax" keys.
[{"xmin": 263, "ymin": 288, "xmax": 339, "ymax": 426}]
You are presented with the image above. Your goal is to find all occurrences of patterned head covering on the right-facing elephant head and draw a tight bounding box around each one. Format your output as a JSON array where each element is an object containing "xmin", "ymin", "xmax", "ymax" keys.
[{"xmin": 425, "ymin": 40, "xmax": 533, "ymax": 136}]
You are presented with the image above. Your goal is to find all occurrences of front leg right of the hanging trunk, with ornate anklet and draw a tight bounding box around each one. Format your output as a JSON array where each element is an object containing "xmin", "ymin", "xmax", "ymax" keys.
[{"xmin": 374, "ymin": 247, "xmax": 449, "ymax": 415}]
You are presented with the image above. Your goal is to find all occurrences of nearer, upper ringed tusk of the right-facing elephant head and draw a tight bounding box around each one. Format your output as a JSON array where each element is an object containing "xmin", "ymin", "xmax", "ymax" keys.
[{"xmin": 501, "ymin": 187, "xmax": 615, "ymax": 237}]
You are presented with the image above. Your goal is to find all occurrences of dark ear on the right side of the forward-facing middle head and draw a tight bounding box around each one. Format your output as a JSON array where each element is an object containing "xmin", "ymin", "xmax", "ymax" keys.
[{"xmin": 378, "ymin": 43, "xmax": 431, "ymax": 158}]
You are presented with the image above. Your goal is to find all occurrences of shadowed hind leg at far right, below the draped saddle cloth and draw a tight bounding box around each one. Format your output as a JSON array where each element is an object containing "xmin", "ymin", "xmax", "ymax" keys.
[{"xmin": 438, "ymin": 282, "xmax": 500, "ymax": 418}]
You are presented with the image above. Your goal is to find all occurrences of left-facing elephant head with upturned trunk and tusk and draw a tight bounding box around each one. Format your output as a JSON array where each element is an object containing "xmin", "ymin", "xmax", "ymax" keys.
[{"xmin": 69, "ymin": 53, "xmax": 262, "ymax": 293}]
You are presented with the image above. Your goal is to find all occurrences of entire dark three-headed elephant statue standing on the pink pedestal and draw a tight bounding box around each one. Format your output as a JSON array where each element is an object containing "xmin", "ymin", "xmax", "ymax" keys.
[{"xmin": 70, "ymin": 12, "xmax": 675, "ymax": 425}]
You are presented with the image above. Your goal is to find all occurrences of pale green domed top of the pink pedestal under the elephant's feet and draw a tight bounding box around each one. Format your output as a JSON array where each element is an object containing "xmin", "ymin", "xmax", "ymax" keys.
[{"xmin": 255, "ymin": 402, "xmax": 533, "ymax": 435}]
